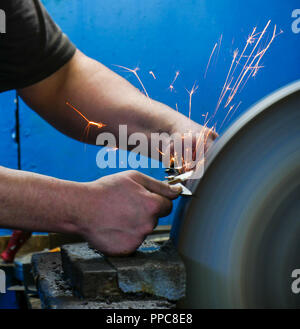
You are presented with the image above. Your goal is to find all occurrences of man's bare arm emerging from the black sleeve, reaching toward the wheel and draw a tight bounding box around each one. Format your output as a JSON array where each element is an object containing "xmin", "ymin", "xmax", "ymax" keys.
[{"xmin": 19, "ymin": 50, "xmax": 215, "ymax": 152}]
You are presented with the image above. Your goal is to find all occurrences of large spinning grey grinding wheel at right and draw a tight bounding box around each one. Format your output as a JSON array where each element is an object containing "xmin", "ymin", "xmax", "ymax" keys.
[{"xmin": 171, "ymin": 81, "xmax": 300, "ymax": 308}]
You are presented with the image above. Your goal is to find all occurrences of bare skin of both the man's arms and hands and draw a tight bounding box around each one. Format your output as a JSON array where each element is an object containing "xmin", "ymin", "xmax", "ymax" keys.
[{"xmin": 0, "ymin": 50, "xmax": 216, "ymax": 255}]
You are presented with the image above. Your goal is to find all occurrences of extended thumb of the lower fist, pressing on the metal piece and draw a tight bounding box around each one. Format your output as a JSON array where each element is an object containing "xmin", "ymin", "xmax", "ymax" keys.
[{"xmin": 133, "ymin": 174, "xmax": 182, "ymax": 200}]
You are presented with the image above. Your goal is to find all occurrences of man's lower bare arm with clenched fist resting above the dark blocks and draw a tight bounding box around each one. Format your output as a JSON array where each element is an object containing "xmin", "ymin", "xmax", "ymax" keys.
[{"xmin": 0, "ymin": 167, "xmax": 180, "ymax": 255}]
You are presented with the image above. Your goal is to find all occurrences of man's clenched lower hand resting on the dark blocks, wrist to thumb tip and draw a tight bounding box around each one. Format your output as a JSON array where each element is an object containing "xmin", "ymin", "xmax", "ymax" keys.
[{"xmin": 73, "ymin": 171, "xmax": 181, "ymax": 255}]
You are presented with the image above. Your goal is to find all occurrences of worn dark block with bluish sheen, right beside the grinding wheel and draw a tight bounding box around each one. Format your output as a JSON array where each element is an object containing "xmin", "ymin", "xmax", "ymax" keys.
[{"xmin": 108, "ymin": 241, "xmax": 186, "ymax": 301}]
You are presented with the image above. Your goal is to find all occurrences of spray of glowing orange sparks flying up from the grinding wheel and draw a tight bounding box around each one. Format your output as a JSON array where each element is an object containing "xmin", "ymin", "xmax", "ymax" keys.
[{"xmin": 114, "ymin": 20, "xmax": 283, "ymax": 172}]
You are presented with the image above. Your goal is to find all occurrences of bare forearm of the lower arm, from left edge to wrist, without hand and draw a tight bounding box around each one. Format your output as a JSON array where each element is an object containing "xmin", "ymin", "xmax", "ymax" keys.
[{"xmin": 0, "ymin": 167, "xmax": 80, "ymax": 233}]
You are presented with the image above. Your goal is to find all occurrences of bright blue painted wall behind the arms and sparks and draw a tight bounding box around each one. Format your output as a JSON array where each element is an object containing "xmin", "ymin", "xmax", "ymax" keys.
[{"xmin": 0, "ymin": 0, "xmax": 300, "ymax": 231}]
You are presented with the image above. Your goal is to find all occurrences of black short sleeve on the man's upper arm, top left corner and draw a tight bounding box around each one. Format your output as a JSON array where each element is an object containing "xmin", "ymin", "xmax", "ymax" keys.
[{"xmin": 0, "ymin": 0, "xmax": 76, "ymax": 92}]
